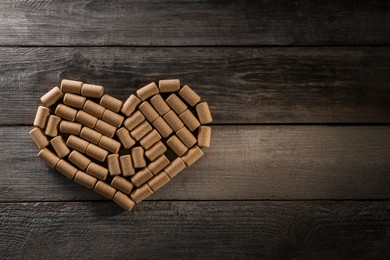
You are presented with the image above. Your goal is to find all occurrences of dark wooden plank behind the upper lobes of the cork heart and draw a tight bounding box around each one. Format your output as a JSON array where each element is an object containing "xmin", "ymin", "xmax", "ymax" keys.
[{"xmin": 0, "ymin": 47, "xmax": 390, "ymax": 125}]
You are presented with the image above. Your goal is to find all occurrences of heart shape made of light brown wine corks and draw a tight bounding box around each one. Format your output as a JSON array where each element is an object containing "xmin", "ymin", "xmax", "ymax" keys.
[{"xmin": 30, "ymin": 79, "xmax": 212, "ymax": 211}]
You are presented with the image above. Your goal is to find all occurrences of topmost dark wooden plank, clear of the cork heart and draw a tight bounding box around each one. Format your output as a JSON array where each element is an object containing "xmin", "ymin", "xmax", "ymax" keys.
[{"xmin": 0, "ymin": 0, "xmax": 390, "ymax": 46}]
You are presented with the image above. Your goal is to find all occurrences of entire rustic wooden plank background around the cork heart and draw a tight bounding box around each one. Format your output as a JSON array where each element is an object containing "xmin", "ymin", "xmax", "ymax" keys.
[{"xmin": 0, "ymin": 0, "xmax": 390, "ymax": 259}]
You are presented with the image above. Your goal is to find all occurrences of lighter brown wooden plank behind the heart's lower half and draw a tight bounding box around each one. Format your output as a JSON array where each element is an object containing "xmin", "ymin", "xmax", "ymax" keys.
[{"xmin": 0, "ymin": 126, "xmax": 390, "ymax": 201}]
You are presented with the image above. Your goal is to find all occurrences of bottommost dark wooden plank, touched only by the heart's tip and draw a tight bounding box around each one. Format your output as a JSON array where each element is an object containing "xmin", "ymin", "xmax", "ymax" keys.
[{"xmin": 0, "ymin": 201, "xmax": 390, "ymax": 259}]
